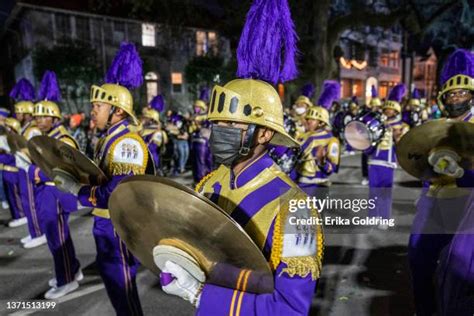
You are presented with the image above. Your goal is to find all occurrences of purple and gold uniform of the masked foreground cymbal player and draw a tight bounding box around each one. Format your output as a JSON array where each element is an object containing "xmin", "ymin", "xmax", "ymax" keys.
[{"xmin": 197, "ymin": 153, "xmax": 323, "ymax": 315}]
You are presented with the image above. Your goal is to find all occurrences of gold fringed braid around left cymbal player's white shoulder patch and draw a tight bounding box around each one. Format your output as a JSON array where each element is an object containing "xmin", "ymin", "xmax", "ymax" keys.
[{"xmin": 107, "ymin": 133, "xmax": 149, "ymax": 176}]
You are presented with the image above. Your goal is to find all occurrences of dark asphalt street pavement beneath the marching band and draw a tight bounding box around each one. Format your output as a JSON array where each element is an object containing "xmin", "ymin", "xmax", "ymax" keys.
[{"xmin": 0, "ymin": 154, "xmax": 420, "ymax": 316}]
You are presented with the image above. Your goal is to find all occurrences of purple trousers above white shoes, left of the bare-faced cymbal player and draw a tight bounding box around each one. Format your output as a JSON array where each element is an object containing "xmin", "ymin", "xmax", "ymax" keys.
[{"xmin": 36, "ymin": 184, "xmax": 80, "ymax": 287}]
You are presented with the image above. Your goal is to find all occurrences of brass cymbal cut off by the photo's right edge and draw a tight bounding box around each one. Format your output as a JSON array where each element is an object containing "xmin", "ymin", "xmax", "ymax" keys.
[{"xmin": 396, "ymin": 119, "xmax": 474, "ymax": 180}]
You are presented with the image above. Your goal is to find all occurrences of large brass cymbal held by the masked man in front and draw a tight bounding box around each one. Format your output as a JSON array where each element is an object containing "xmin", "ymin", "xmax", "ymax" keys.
[{"xmin": 109, "ymin": 175, "xmax": 273, "ymax": 293}]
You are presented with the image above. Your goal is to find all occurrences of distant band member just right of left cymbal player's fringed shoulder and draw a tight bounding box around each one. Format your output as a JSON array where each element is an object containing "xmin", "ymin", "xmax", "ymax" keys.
[{"xmin": 140, "ymin": 94, "xmax": 168, "ymax": 175}]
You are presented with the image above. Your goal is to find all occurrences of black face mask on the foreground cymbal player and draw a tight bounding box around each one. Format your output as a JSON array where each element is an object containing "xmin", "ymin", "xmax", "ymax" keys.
[{"xmin": 209, "ymin": 124, "xmax": 254, "ymax": 167}]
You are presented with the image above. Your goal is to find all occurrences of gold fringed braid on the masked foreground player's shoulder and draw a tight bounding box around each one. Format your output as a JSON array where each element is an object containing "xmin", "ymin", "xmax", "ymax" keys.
[{"xmin": 270, "ymin": 201, "xmax": 324, "ymax": 281}]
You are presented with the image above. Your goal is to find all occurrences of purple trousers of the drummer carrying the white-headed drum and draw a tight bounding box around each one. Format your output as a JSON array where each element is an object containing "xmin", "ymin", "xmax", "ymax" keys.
[{"xmin": 369, "ymin": 165, "xmax": 394, "ymax": 219}]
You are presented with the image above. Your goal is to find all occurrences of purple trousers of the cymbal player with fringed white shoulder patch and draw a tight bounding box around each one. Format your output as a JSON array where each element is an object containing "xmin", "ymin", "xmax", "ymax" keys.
[{"xmin": 93, "ymin": 216, "xmax": 143, "ymax": 315}]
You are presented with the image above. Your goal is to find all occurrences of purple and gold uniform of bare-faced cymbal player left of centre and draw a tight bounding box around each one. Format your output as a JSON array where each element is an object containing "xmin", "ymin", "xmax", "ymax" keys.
[{"xmin": 78, "ymin": 120, "xmax": 149, "ymax": 315}]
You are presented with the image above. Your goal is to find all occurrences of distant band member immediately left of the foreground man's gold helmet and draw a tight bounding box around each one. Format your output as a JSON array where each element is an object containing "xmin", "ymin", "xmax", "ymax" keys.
[{"xmin": 190, "ymin": 88, "xmax": 213, "ymax": 184}]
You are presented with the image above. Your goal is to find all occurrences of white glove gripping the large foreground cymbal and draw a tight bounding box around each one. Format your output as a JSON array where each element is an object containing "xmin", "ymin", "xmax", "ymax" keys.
[{"xmin": 162, "ymin": 261, "xmax": 203, "ymax": 307}]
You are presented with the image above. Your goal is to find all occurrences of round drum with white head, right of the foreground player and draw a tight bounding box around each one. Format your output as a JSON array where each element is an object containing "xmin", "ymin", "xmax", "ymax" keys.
[{"xmin": 344, "ymin": 112, "xmax": 385, "ymax": 151}]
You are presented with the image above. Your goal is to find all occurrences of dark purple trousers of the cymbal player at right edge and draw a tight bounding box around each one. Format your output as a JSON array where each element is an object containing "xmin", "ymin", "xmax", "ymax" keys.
[{"xmin": 408, "ymin": 188, "xmax": 467, "ymax": 316}]
